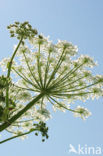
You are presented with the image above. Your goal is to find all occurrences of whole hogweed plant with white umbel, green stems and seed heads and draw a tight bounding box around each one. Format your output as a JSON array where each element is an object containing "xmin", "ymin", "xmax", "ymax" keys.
[{"xmin": 0, "ymin": 22, "xmax": 103, "ymax": 143}]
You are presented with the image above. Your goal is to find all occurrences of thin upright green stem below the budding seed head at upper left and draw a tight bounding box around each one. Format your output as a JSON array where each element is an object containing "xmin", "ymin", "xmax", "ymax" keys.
[{"xmin": 6, "ymin": 37, "xmax": 23, "ymax": 108}]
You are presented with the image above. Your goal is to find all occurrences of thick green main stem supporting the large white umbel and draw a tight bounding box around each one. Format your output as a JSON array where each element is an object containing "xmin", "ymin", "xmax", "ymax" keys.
[{"xmin": 0, "ymin": 93, "xmax": 45, "ymax": 132}]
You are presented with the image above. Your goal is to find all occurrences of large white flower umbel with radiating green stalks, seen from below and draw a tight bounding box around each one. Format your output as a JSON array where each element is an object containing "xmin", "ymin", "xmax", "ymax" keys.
[{"xmin": 4, "ymin": 35, "xmax": 103, "ymax": 122}]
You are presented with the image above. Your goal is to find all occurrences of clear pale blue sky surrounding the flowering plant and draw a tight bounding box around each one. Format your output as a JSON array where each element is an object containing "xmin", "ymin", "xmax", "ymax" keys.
[{"xmin": 0, "ymin": 0, "xmax": 103, "ymax": 156}]
